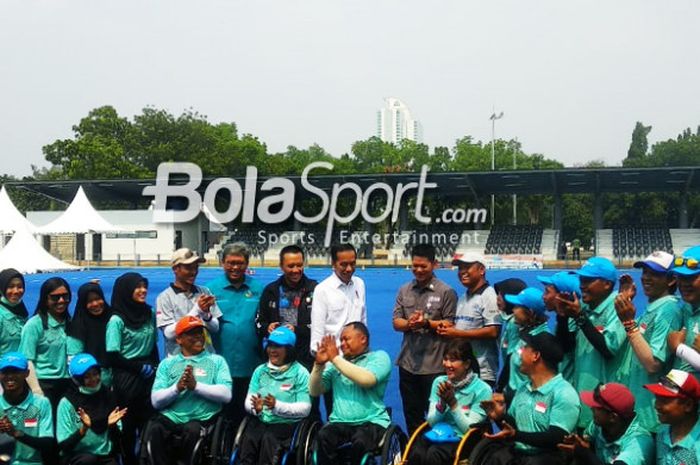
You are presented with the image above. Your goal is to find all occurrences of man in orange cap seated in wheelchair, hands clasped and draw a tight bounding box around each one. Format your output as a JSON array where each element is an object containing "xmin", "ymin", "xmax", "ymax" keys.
[{"xmin": 147, "ymin": 315, "xmax": 231, "ymax": 465}]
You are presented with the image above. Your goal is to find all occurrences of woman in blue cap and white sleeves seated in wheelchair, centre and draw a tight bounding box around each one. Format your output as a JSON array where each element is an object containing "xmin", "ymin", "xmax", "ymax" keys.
[{"xmin": 239, "ymin": 326, "xmax": 311, "ymax": 465}]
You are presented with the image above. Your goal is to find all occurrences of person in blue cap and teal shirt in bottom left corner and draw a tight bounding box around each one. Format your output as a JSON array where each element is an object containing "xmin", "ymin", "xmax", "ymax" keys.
[{"xmin": 0, "ymin": 352, "xmax": 55, "ymax": 465}]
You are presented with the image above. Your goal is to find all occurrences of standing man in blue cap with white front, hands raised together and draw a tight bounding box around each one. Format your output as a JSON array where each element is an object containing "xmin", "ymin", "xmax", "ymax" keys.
[{"xmin": 615, "ymin": 251, "xmax": 681, "ymax": 433}]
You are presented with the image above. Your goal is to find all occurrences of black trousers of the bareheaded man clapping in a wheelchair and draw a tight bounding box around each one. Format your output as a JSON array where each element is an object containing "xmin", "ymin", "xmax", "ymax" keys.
[{"xmin": 316, "ymin": 423, "xmax": 386, "ymax": 465}]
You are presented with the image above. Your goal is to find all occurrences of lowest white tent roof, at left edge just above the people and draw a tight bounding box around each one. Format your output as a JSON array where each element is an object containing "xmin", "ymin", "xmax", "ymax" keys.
[{"xmin": 0, "ymin": 228, "xmax": 79, "ymax": 273}]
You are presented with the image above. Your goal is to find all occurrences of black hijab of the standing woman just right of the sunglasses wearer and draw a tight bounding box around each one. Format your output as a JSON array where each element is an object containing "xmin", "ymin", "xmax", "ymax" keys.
[{"xmin": 68, "ymin": 283, "xmax": 112, "ymax": 365}]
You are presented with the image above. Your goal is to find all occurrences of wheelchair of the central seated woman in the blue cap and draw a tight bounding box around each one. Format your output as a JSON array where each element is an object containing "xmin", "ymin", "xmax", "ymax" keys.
[{"xmin": 228, "ymin": 416, "xmax": 321, "ymax": 465}]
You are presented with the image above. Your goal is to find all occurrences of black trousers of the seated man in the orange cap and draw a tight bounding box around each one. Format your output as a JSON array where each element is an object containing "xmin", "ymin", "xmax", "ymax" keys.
[{"xmin": 147, "ymin": 414, "xmax": 216, "ymax": 465}]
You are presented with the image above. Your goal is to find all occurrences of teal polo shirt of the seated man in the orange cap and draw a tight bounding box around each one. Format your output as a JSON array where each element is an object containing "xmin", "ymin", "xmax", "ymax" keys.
[{"xmin": 153, "ymin": 350, "xmax": 231, "ymax": 425}]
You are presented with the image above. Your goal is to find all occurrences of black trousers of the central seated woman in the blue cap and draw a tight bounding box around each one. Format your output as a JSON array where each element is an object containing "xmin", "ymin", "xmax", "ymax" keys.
[{"xmin": 239, "ymin": 417, "xmax": 296, "ymax": 465}]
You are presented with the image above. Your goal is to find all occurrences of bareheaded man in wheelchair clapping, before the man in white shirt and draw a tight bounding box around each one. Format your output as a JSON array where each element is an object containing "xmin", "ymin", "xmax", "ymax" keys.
[{"xmin": 309, "ymin": 322, "xmax": 391, "ymax": 465}]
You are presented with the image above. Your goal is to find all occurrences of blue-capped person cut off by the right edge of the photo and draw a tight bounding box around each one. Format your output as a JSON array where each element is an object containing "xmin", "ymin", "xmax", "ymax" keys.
[{"xmin": 669, "ymin": 245, "xmax": 700, "ymax": 378}]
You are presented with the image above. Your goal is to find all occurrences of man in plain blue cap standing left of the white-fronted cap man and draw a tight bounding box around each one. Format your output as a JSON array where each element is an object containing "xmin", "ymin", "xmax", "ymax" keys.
[{"xmin": 557, "ymin": 257, "xmax": 625, "ymax": 428}]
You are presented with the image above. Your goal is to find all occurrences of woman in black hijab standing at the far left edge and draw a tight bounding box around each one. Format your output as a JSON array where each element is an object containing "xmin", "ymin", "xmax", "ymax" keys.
[{"xmin": 0, "ymin": 268, "xmax": 29, "ymax": 354}]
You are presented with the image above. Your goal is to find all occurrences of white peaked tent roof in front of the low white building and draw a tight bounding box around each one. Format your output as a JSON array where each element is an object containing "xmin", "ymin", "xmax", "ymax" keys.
[{"xmin": 36, "ymin": 186, "xmax": 123, "ymax": 235}]
